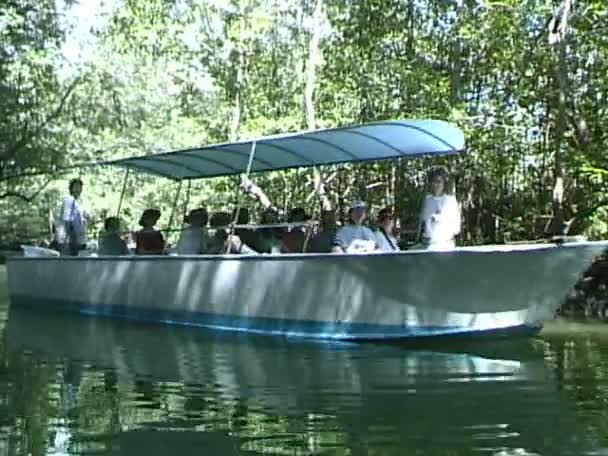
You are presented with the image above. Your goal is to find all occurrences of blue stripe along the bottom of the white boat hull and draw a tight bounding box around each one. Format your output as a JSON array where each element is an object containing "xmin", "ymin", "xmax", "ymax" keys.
[{"xmin": 11, "ymin": 295, "xmax": 542, "ymax": 341}]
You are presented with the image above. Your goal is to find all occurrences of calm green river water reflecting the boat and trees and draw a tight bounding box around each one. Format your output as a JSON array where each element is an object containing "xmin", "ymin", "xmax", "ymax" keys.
[{"xmin": 0, "ymin": 270, "xmax": 608, "ymax": 456}]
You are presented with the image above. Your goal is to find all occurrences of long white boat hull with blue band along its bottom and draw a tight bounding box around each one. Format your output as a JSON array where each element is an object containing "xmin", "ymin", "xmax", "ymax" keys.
[{"xmin": 8, "ymin": 242, "xmax": 608, "ymax": 339}]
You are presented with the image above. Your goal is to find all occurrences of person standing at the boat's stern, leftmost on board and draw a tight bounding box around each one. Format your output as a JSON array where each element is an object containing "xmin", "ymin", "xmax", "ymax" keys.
[{"xmin": 55, "ymin": 179, "xmax": 87, "ymax": 256}]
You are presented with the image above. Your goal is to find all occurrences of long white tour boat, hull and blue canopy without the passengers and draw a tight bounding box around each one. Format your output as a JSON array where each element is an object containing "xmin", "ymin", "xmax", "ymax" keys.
[{"xmin": 7, "ymin": 120, "xmax": 608, "ymax": 341}]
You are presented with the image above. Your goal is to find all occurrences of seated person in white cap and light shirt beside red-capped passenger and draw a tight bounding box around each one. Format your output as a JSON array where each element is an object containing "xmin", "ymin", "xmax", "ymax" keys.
[{"xmin": 332, "ymin": 201, "xmax": 377, "ymax": 253}]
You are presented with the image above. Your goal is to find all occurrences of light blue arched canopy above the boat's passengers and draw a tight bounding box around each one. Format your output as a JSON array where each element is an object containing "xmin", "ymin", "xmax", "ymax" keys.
[{"xmin": 103, "ymin": 120, "xmax": 465, "ymax": 180}]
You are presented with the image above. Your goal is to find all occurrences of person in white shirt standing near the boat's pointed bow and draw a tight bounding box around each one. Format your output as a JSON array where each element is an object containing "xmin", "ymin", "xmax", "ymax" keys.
[{"xmin": 419, "ymin": 168, "xmax": 460, "ymax": 249}]
